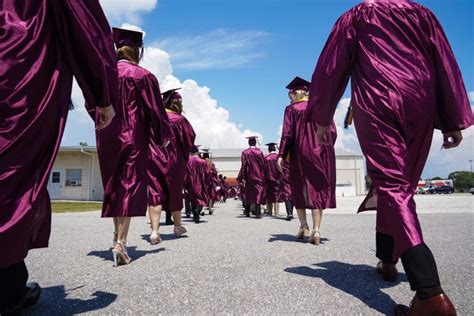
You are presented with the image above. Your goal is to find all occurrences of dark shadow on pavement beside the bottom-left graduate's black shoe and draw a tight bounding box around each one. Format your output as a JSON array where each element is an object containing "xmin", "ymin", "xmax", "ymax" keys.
[{"xmin": 23, "ymin": 285, "xmax": 117, "ymax": 315}]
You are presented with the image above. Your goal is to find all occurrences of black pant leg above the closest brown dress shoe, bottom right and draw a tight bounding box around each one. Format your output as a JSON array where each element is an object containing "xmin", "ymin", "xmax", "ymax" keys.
[{"xmin": 401, "ymin": 244, "xmax": 441, "ymax": 291}]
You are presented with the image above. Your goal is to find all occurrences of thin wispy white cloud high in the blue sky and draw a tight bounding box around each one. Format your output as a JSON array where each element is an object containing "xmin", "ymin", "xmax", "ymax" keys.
[{"xmin": 155, "ymin": 29, "xmax": 269, "ymax": 70}]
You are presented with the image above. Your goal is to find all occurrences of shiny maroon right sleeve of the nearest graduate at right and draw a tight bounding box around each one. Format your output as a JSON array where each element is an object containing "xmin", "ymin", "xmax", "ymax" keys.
[{"xmin": 427, "ymin": 10, "xmax": 473, "ymax": 132}]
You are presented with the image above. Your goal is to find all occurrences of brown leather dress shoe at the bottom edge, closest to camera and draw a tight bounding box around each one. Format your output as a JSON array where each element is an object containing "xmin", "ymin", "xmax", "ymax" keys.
[{"xmin": 395, "ymin": 294, "xmax": 456, "ymax": 316}]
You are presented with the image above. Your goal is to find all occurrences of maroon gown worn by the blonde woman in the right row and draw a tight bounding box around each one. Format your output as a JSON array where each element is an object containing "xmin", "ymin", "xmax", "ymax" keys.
[{"xmin": 280, "ymin": 101, "xmax": 336, "ymax": 209}]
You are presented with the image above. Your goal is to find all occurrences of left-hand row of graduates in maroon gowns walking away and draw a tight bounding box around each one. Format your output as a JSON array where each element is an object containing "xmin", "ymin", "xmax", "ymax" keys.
[{"xmin": 0, "ymin": 0, "xmax": 228, "ymax": 315}]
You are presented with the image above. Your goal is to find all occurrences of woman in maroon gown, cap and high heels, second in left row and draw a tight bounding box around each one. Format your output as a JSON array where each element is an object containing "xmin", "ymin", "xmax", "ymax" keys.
[{"xmin": 94, "ymin": 28, "xmax": 171, "ymax": 266}]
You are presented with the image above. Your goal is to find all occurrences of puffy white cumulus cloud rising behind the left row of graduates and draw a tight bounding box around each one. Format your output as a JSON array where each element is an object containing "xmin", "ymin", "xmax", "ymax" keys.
[{"xmin": 63, "ymin": 24, "xmax": 263, "ymax": 148}]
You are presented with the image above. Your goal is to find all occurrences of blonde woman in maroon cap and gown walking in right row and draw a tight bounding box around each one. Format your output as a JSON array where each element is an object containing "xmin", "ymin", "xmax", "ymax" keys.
[{"xmin": 278, "ymin": 77, "xmax": 336, "ymax": 245}]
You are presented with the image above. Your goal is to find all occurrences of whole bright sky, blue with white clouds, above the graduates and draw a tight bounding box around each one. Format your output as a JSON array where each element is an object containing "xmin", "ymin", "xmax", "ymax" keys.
[{"xmin": 63, "ymin": 0, "xmax": 474, "ymax": 177}]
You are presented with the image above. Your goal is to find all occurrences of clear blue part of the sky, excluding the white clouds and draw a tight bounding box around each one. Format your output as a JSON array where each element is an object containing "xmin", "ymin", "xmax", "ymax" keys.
[{"xmin": 143, "ymin": 0, "xmax": 474, "ymax": 140}]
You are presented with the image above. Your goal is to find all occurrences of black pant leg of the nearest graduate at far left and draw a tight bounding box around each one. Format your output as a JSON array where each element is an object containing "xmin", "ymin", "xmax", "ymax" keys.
[{"xmin": 0, "ymin": 260, "xmax": 28, "ymax": 313}]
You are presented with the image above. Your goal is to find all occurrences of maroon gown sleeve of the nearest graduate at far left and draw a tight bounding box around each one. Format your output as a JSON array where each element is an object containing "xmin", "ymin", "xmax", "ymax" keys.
[{"xmin": 51, "ymin": 0, "xmax": 118, "ymax": 109}]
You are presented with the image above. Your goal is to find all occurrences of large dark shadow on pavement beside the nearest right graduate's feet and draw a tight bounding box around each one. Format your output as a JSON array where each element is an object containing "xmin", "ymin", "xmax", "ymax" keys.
[{"xmin": 285, "ymin": 261, "xmax": 407, "ymax": 314}]
